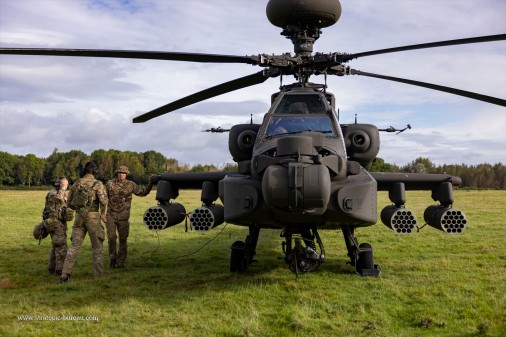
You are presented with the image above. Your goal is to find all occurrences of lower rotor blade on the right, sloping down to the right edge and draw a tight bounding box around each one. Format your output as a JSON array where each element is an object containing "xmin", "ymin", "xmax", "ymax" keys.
[{"xmin": 350, "ymin": 69, "xmax": 506, "ymax": 106}]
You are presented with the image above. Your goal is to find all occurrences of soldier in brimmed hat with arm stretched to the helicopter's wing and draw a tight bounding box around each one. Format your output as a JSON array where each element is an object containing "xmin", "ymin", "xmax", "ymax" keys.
[{"xmin": 105, "ymin": 166, "xmax": 153, "ymax": 268}]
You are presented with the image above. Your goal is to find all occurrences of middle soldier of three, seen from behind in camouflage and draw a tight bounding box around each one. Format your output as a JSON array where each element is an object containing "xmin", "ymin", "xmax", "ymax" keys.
[{"xmin": 60, "ymin": 162, "xmax": 108, "ymax": 282}]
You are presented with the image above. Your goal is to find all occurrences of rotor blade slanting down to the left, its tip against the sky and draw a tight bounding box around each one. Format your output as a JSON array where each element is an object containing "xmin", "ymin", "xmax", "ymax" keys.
[{"xmin": 133, "ymin": 69, "xmax": 279, "ymax": 123}]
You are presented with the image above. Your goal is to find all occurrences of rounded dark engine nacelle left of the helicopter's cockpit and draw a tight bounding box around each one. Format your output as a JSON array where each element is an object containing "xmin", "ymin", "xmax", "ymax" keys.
[{"xmin": 228, "ymin": 124, "xmax": 260, "ymax": 163}]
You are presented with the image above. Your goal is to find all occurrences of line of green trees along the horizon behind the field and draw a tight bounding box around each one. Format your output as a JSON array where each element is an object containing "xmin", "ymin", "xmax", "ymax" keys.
[{"xmin": 0, "ymin": 149, "xmax": 506, "ymax": 189}]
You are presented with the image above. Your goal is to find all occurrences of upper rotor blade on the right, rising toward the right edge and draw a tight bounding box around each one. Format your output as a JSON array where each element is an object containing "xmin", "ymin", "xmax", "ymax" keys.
[{"xmin": 337, "ymin": 34, "xmax": 506, "ymax": 62}]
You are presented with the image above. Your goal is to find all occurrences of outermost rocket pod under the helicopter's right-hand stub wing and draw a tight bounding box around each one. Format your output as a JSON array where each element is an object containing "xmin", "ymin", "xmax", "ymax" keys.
[{"xmin": 423, "ymin": 205, "xmax": 467, "ymax": 234}]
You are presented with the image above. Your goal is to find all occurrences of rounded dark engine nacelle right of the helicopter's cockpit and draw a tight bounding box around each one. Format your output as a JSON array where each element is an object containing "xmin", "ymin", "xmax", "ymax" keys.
[{"xmin": 341, "ymin": 124, "xmax": 380, "ymax": 169}]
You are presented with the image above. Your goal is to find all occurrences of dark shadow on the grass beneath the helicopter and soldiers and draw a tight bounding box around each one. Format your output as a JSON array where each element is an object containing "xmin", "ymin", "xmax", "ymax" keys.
[{"xmin": 0, "ymin": 227, "xmax": 364, "ymax": 307}]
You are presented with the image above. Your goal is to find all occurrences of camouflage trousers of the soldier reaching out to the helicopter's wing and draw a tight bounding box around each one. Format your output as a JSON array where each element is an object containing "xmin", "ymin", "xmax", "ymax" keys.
[{"xmin": 106, "ymin": 214, "xmax": 130, "ymax": 267}]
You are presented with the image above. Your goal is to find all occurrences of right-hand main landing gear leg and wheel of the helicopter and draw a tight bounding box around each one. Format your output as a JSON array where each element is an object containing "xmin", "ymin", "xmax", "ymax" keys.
[{"xmin": 342, "ymin": 226, "xmax": 381, "ymax": 277}]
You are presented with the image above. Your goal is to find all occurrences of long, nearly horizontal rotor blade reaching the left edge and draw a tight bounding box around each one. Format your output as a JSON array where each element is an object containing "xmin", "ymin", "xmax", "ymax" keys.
[{"xmin": 0, "ymin": 48, "xmax": 259, "ymax": 64}]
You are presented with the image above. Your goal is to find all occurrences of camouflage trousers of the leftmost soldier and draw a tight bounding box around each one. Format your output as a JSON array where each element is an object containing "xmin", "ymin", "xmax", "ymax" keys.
[{"xmin": 44, "ymin": 219, "xmax": 67, "ymax": 274}]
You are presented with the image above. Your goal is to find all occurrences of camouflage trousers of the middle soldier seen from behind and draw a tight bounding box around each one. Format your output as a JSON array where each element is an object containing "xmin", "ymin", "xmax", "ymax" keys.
[{"xmin": 62, "ymin": 212, "xmax": 105, "ymax": 278}]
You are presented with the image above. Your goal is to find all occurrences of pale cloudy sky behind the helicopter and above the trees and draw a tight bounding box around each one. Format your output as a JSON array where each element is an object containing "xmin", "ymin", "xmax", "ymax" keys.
[{"xmin": 0, "ymin": 0, "xmax": 506, "ymax": 165}]
